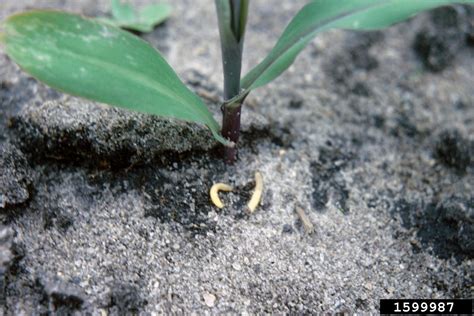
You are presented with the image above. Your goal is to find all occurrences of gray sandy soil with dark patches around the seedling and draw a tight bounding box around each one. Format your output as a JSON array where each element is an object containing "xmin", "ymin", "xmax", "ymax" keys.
[{"xmin": 0, "ymin": 0, "xmax": 474, "ymax": 315}]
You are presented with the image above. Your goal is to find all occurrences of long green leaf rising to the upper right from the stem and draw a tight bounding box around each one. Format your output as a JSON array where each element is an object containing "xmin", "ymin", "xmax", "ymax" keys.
[{"xmin": 241, "ymin": 0, "xmax": 474, "ymax": 92}]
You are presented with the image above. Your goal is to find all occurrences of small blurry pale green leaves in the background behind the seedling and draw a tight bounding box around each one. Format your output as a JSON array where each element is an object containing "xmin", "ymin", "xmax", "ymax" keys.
[{"xmin": 103, "ymin": 0, "xmax": 173, "ymax": 32}]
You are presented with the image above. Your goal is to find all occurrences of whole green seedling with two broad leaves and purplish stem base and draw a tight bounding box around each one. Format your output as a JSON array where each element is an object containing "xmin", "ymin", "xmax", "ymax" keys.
[{"xmin": 0, "ymin": 0, "xmax": 474, "ymax": 163}]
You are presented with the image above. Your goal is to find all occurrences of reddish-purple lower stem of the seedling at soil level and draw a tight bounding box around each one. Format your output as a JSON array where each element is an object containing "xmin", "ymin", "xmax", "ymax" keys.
[{"xmin": 221, "ymin": 104, "xmax": 242, "ymax": 164}]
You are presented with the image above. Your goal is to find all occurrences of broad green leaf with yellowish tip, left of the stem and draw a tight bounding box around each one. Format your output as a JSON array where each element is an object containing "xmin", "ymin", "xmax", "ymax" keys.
[{"xmin": 3, "ymin": 11, "xmax": 228, "ymax": 143}]
